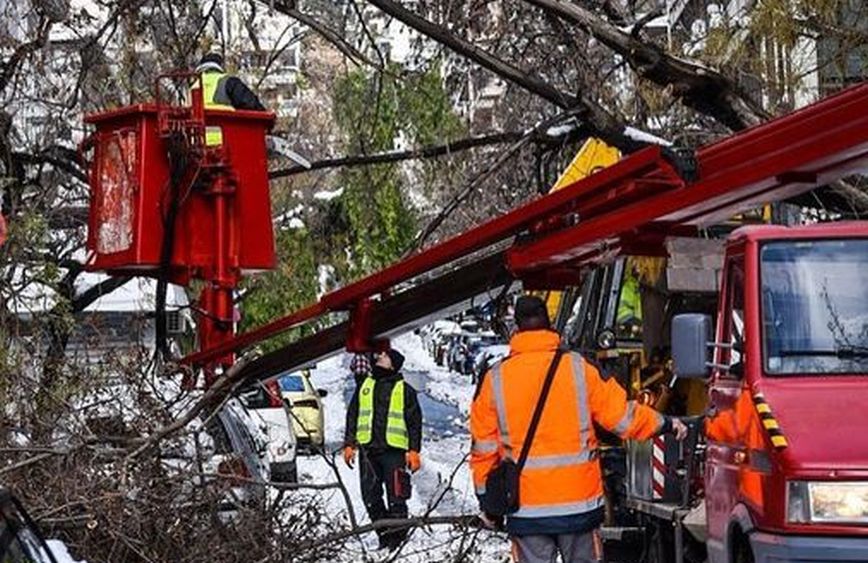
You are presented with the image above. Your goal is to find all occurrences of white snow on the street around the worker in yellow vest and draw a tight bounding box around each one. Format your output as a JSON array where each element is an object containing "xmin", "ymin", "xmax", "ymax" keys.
[{"xmin": 298, "ymin": 334, "xmax": 509, "ymax": 562}]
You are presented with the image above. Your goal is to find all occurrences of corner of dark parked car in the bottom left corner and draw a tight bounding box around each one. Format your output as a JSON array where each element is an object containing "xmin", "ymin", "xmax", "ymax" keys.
[{"xmin": 0, "ymin": 486, "xmax": 57, "ymax": 563}]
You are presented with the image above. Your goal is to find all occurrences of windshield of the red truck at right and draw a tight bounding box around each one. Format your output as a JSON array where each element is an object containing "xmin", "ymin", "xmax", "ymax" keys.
[{"xmin": 760, "ymin": 240, "xmax": 868, "ymax": 374}]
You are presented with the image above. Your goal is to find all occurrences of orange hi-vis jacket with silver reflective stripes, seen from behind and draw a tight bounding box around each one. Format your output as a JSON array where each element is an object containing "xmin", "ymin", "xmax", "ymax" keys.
[{"xmin": 470, "ymin": 330, "xmax": 664, "ymax": 518}]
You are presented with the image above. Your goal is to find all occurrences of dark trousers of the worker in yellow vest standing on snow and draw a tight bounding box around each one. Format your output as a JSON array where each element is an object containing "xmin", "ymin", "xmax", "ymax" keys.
[{"xmin": 359, "ymin": 447, "xmax": 407, "ymax": 546}]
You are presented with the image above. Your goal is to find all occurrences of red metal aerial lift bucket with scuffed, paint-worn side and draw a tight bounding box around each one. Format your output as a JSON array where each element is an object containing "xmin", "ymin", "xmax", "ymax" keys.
[{"xmin": 85, "ymin": 104, "xmax": 275, "ymax": 283}]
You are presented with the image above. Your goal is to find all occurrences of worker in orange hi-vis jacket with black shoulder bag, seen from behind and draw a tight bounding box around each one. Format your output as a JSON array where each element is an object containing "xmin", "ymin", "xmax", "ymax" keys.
[{"xmin": 470, "ymin": 296, "xmax": 687, "ymax": 563}]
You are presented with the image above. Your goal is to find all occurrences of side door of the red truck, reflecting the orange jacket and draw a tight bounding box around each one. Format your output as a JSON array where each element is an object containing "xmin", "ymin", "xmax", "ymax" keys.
[{"xmin": 705, "ymin": 254, "xmax": 745, "ymax": 563}]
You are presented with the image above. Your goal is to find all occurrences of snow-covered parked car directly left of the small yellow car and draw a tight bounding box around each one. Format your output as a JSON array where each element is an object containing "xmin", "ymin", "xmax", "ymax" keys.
[{"xmin": 241, "ymin": 380, "xmax": 298, "ymax": 482}]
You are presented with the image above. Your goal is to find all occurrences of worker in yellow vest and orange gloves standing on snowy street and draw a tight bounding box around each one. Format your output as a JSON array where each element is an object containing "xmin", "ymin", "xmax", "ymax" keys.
[{"xmin": 344, "ymin": 350, "xmax": 422, "ymax": 549}]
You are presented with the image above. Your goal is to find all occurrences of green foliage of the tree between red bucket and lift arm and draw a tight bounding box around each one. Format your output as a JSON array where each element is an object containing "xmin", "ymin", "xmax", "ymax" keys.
[{"xmin": 241, "ymin": 60, "xmax": 464, "ymax": 349}]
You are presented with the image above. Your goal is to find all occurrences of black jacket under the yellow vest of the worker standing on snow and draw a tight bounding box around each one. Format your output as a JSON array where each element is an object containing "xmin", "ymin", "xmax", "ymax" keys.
[{"xmin": 344, "ymin": 372, "xmax": 422, "ymax": 452}]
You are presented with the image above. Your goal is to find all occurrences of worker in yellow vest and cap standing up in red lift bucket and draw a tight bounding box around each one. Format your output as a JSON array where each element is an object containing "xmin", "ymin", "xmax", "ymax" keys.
[{"xmin": 196, "ymin": 53, "xmax": 265, "ymax": 146}]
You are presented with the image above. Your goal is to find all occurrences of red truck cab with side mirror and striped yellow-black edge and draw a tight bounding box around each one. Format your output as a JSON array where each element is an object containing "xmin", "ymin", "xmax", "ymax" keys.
[{"xmin": 672, "ymin": 223, "xmax": 868, "ymax": 563}]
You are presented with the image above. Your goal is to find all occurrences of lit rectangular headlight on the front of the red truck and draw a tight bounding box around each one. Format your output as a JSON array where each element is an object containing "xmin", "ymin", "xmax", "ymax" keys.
[{"xmin": 787, "ymin": 481, "xmax": 868, "ymax": 524}]
